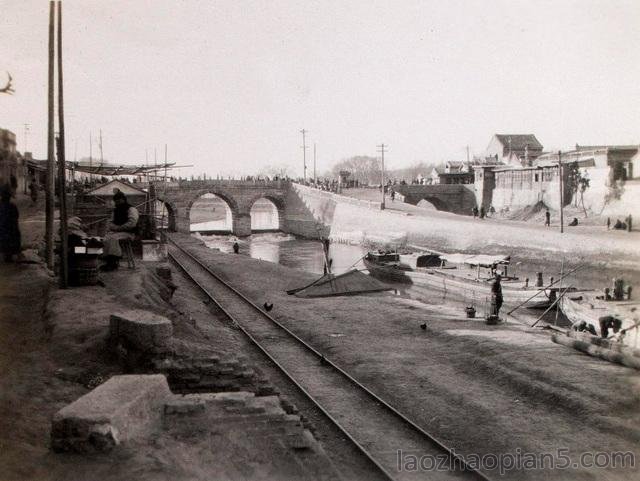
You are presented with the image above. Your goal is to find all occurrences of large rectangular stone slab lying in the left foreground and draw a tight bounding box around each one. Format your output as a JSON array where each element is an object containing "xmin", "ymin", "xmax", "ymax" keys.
[{"xmin": 51, "ymin": 374, "xmax": 172, "ymax": 452}]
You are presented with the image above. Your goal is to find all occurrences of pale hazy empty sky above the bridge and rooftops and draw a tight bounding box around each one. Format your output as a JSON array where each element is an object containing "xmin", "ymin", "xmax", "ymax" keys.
[{"xmin": 0, "ymin": 0, "xmax": 640, "ymax": 176}]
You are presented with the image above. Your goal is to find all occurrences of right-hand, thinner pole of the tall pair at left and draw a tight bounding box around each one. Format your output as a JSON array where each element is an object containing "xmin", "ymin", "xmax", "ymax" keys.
[{"xmin": 58, "ymin": 0, "xmax": 69, "ymax": 289}]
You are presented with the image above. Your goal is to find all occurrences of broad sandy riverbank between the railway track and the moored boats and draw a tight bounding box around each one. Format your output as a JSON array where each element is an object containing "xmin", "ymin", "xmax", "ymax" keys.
[{"xmin": 172, "ymin": 232, "xmax": 640, "ymax": 479}]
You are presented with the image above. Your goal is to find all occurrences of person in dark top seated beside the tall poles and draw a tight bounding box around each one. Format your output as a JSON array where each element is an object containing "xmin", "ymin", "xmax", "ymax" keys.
[{"xmin": 101, "ymin": 191, "xmax": 139, "ymax": 271}]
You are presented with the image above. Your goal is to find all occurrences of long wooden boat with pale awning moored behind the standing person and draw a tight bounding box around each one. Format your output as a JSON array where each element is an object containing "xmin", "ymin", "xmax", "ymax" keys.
[{"xmin": 363, "ymin": 251, "xmax": 575, "ymax": 309}]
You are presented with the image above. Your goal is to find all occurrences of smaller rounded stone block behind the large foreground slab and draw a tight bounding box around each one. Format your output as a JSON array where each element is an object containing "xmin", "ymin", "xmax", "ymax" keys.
[{"xmin": 109, "ymin": 309, "xmax": 173, "ymax": 353}]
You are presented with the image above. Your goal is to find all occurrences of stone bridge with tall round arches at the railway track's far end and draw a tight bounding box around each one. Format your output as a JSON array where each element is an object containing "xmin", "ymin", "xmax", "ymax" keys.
[{"xmin": 154, "ymin": 180, "xmax": 290, "ymax": 236}]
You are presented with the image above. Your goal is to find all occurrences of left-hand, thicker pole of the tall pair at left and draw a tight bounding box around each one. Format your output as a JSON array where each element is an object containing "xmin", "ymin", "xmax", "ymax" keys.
[{"xmin": 45, "ymin": 1, "xmax": 56, "ymax": 269}]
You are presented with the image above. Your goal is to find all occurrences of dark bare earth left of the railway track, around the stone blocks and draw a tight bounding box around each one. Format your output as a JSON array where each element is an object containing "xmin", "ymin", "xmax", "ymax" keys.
[{"xmin": 0, "ymin": 192, "xmax": 356, "ymax": 481}]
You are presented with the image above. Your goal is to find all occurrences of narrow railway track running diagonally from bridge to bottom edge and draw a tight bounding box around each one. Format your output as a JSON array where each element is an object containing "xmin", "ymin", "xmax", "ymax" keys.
[{"xmin": 167, "ymin": 236, "xmax": 489, "ymax": 481}]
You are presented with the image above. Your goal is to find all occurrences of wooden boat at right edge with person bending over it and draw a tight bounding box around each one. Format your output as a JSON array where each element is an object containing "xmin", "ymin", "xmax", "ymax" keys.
[{"xmin": 559, "ymin": 291, "xmax": 640, "ymax": 348}]
